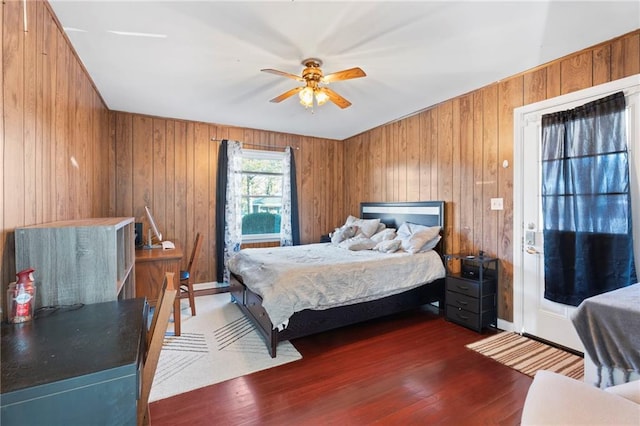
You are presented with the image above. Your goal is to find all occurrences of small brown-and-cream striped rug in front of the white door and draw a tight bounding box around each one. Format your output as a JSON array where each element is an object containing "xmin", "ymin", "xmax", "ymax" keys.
[{"xmin": 467, "ymin": 332, "xmax": 584, "ymax": 380}]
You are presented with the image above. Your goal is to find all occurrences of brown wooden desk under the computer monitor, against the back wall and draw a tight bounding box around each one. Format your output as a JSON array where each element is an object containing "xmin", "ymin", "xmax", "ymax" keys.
[{"xmin": 136, "ymin": 244, "xmax": 182, "ymax": 336}]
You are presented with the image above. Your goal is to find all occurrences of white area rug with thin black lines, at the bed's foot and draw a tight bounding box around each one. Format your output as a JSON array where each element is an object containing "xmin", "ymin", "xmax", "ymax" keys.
[{"xmin": 149, "ymin": 293, "xmax": 302, "ymax": 401}]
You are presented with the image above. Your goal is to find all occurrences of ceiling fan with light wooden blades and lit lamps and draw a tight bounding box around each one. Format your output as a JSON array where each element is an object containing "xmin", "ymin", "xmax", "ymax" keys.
[{"xmin": 260, "ymin": 58, "xmax": 366, "ymax": 109}]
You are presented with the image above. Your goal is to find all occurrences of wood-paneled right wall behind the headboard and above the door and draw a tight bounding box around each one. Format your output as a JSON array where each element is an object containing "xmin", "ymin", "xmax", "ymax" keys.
[{"xmin": 344, "ymin": 30, "xmax": 640, "ymax": 321}]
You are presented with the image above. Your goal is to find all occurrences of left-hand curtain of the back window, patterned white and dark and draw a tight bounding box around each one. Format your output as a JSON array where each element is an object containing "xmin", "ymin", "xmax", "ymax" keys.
[{"xmin": 216, "ymin": 140, "xmax": 242, "ymax": 283}]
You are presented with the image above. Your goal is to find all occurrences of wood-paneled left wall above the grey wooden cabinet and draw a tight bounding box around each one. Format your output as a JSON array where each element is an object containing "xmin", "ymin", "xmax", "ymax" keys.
[{"xmin": 0, "ymin": 1, "xmax": 109, "ymax": 290}]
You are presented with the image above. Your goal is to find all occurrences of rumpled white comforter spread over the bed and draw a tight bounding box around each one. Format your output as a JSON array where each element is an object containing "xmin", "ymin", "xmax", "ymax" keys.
[{"xmin": 229, "ymin": 243, "xmax": 445, "ymax": 330}]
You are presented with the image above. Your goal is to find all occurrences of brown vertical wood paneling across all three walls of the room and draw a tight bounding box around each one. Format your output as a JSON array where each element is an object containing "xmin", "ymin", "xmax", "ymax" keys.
[{"xmin": 0, "ymin": 0, "xmax": 640, "ymax": 320}]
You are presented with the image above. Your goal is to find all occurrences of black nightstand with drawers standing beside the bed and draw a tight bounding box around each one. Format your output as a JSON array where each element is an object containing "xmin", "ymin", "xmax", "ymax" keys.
[{"xmin": 444, "ymin": 252, "xmax": 498, "ymax": 332}]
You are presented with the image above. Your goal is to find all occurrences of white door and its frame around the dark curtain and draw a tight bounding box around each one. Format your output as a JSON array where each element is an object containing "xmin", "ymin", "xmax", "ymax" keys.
[{"xmin": 513, "ymin": 74, "xmax": 640, "ymax": 352}]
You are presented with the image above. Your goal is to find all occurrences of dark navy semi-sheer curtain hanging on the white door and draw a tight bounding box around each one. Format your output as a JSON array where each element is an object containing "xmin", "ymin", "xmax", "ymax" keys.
[{"xmin": 542, "ymin": 92, "xmax": 637, "ymax": 306}]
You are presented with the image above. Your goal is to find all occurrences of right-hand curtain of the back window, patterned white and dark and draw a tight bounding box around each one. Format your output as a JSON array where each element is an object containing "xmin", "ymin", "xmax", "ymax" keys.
[{"xmin": 280, "ymin": 147, "xmax": 300, "ymax": 246}]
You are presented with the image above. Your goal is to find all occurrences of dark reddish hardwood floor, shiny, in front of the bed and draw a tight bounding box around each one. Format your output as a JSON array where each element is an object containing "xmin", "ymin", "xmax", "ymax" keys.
[{"xmin": 150, "ymin": 309, "xmax": 532, "ymax": 426}]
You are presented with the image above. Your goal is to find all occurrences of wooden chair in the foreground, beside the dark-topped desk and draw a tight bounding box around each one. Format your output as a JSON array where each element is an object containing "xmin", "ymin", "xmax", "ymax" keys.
[{"xmin": 138, "ymin": 272, "xmax": 177, "ymax": 426}]
